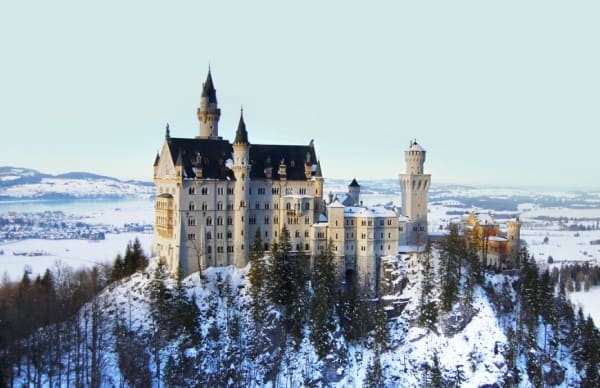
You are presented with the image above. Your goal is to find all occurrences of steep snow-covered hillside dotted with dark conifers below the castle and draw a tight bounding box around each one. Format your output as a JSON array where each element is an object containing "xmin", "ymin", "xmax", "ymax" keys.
[{"xmin": 4, "ymin": 242, "xmax": 599, "ymax": 387}]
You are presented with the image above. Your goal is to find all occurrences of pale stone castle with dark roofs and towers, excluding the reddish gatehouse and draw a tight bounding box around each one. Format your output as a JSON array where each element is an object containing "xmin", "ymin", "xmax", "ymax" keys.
[{"xmin": 153, "ymin": 70, "xmax": 431, "ymax": 291}]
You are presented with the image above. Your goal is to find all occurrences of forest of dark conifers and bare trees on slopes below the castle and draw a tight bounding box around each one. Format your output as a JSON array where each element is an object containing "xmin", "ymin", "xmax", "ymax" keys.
[{"xmin": 0, "ymin": 228, "xmax": 600, "ymax": 387}]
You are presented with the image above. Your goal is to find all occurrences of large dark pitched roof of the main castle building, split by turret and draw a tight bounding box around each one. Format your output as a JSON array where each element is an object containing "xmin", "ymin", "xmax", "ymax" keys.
[{"xmin": 166, "ymin": 137, "xmax": 319, "ymax": 180}]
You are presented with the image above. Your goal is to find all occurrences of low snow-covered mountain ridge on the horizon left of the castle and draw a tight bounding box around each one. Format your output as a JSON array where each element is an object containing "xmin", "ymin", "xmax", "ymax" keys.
[{"xmin": 0, "ymin": 166, "xmax": 154, "ymax": 201}]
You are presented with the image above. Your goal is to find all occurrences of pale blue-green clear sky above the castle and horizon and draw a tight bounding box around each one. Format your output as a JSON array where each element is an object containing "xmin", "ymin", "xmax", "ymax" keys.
[{"xmin": 0, "ymin": 0, "xmax": 600, "ymax": 189}]
